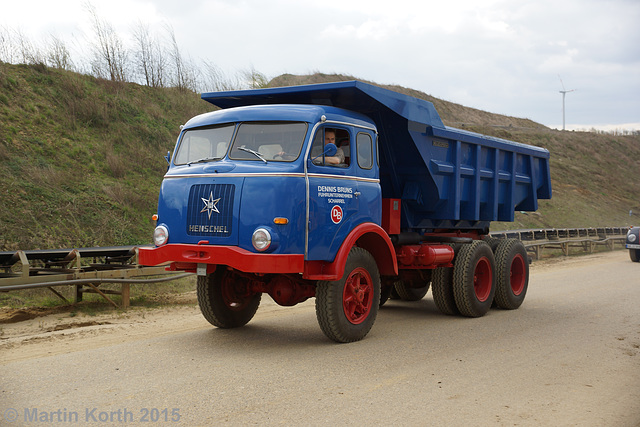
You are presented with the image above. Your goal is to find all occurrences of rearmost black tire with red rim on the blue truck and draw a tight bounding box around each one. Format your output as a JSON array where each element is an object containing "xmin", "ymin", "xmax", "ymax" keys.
[{"xmin": 495, "ymin": 239, "xmax": 529, "ymax": 310}]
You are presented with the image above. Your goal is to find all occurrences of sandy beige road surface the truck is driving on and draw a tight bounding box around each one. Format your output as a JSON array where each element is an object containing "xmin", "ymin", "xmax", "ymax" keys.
[{"xmin": 0, "ymin": 251, "xmax": 640, "ymax": 426}]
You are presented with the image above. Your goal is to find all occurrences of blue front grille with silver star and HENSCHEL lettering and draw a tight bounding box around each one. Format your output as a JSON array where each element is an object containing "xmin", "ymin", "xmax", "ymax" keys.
[{"xmin": 187, "ymin": 184, "xmax": 235, "ymax": 237}]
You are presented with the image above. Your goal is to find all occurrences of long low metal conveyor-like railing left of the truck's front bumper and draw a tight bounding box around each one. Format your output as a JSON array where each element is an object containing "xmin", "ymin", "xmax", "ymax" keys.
[{"xmin": 0, "ymin": 246, "xmax": 191, "ymax": 308}]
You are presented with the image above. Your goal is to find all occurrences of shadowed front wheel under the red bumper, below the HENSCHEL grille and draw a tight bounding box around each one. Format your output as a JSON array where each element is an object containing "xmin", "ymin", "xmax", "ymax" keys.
[{"xmin": 196, "ymin": 266, "xmax": 262, "ymax": 329}]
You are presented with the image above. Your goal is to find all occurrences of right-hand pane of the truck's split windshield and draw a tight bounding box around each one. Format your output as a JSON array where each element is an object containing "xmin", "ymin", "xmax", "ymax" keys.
[{"xmin": 229, "ymin": 122, "xmax": 307, "ymax": 162}]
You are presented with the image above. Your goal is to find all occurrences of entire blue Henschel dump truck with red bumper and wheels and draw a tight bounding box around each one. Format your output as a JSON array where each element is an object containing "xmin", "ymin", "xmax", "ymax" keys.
[{"xmin": 139, "ymin": 81, "xmax": 551, "ymax": 342}]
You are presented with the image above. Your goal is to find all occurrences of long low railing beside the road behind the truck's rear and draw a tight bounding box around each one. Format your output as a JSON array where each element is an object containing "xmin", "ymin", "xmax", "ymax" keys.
[{"xmin": 490, "ymin": 227, "xmax": 629, "ymax": 259}]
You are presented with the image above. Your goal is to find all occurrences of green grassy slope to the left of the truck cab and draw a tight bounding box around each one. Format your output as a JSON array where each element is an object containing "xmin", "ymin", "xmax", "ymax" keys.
[{"xmin": 0, "ymin": 63, "xmax": 210, "ymax": 250}]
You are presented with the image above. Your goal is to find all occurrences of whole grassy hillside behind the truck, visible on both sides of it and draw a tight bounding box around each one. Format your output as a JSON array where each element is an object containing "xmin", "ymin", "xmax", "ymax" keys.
[{"xmin": 0, "ymin": 63, "xmax": 640, "ymax": 250}]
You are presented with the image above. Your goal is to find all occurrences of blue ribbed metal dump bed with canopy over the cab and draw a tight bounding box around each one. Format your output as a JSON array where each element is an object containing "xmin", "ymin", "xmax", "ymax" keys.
[{"xmin": 202, "ymin": 81, "xmax": 551, "ymax": 231}]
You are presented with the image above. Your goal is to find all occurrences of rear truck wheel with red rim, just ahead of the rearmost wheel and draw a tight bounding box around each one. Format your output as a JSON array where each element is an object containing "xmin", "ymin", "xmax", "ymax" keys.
[{"xmin": 453, "ymin": 240, "xmax": 496, "ymax": 317}]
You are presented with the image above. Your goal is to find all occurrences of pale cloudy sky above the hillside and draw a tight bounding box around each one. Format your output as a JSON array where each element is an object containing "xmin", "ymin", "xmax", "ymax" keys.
[{"xmin": 0, "ymin": 0, "xmax": 640, "ymax": 130}]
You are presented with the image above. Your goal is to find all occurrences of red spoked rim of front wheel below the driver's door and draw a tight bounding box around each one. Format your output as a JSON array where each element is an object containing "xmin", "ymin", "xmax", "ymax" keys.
[{"xmin": 342, "ymin": 267, "xmax": 373, "ymax": 325}]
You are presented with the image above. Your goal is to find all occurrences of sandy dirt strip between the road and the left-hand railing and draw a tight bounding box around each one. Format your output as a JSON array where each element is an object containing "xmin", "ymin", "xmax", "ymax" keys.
[{"xmin": 0, "ymin": 291, "xmax": 296, "ymax": 364}]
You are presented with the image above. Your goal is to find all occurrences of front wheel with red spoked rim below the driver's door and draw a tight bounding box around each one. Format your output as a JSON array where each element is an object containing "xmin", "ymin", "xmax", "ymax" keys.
[{"xmin": 316, "ymin": 247, "xmax": 380, "ymax": 343}]
